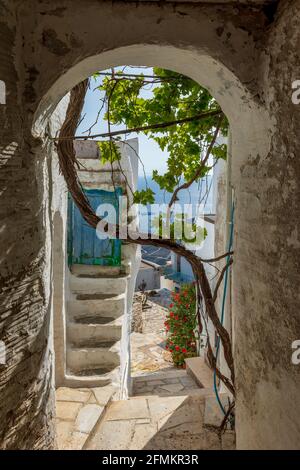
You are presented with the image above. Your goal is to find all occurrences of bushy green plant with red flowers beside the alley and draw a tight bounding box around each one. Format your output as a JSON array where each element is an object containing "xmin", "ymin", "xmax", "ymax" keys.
[{"xmin": 165, "ymin": 284, "xmax": 197, "ymax": 367}]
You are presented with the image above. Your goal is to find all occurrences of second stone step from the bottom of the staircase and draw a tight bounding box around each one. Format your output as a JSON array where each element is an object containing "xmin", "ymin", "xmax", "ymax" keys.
[{"xmin": 67, "ymin": 342, "xmax": 120, "ymax": 375}]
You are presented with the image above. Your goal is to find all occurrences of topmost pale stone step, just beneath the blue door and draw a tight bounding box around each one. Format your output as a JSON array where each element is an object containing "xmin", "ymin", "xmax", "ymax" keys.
[{"xmin": 69, "ymin": 274, "xmax": 127, "ymax": 295}]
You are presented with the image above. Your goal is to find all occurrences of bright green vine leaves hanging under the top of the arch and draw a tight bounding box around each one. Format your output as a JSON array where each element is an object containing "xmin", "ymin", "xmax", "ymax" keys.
[{"xmin": 99, "ymin": 67, "xmax": 228, "ymax": 203}]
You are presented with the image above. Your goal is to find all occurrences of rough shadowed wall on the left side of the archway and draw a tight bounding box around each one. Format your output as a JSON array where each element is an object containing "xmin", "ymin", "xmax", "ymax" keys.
[{"xmin": 0, "ymin": 1, "xmax": 54, "ymax": 449}]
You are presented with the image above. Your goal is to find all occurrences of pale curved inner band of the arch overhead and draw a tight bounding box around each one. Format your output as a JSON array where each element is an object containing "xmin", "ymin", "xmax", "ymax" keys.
[{"xmin": 33, "ymin": 45, "xmax": 268, "ymax": 448}]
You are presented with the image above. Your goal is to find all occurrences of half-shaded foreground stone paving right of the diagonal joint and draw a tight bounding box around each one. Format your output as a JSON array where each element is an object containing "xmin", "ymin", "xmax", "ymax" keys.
[{"xmin": 85, "ymin": 395, "xmax": 234, "ymax": 450}]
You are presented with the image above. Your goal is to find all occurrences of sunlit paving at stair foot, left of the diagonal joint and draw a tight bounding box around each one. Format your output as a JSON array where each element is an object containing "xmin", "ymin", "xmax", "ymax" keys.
[{"xmin": 56, "ymin": 386, "xmax": 115, "ymax": 450}]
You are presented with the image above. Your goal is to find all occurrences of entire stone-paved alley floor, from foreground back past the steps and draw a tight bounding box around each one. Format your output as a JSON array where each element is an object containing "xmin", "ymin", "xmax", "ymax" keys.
[{"xmin": 57, "ymin": 290, "xmax": 234, "ymax": 450}]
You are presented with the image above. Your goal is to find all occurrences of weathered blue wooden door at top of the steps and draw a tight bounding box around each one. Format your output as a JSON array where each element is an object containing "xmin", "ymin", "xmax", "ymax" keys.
[{"xmin": 68, "ymin": 188, "xmax": 122, "ymax": 266}]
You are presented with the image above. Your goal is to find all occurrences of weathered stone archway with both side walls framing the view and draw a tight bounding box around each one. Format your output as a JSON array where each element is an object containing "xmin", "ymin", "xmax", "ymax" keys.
[{"xmin": 0, "ymin": 0, "xmax": 300, "ymax": 448}]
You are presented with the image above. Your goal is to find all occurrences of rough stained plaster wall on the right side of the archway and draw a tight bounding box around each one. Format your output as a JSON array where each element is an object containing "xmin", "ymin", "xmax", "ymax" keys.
[{"xmin": 233, "ymin": 1, "xmax": 300, "ymax": 449}]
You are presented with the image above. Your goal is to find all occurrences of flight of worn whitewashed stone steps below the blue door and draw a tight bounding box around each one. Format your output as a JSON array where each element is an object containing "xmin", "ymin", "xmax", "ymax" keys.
[{"xmin": 66, "ymin": 265, "xmax": 127, "ymax": 387}]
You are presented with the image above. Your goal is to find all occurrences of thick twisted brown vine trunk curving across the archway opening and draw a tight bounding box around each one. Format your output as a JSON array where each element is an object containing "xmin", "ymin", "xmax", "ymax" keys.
[{"xmin": 56, "ymin": 80, "xmax": 235, "ymax": 396}]
